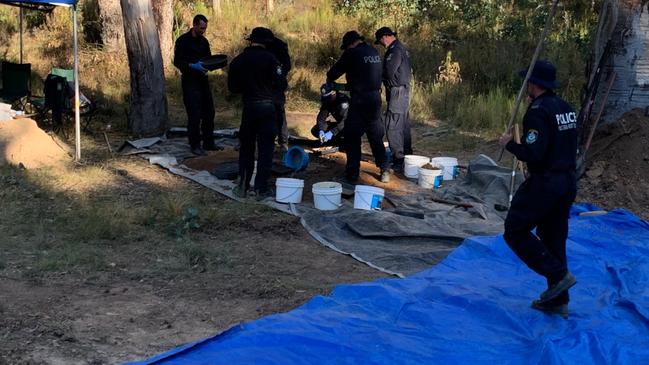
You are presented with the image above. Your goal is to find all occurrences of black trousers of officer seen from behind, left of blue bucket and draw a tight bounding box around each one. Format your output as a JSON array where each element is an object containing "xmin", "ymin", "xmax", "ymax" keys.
[{"xmin": 239, "ymin": 100, "xmax": 277, "ymax": 192}]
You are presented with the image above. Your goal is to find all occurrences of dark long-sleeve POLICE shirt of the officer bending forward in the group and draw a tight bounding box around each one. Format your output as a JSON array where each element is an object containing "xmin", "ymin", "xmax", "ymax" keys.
[{"xmin": 327, "ymin": 42, "xmax": 383, "ymax": 96}]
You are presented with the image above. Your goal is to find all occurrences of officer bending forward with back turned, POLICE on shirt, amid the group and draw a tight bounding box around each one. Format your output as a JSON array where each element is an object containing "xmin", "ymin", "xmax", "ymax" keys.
[{"xmin": 327, "ymin": 30, "xmax": 390, "ymax": 184}]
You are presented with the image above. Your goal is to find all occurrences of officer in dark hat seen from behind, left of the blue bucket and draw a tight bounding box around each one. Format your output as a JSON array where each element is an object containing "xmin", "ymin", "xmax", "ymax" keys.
[{"xmin": 228, "ymin": 27, "xmax": 286, "ymax": 199}]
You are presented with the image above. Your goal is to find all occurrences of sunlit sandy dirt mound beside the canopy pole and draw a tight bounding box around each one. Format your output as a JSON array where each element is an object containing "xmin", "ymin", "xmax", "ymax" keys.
[{"xmin": 0, "ymin": 118, "xmax": 69, "ymax": 169}]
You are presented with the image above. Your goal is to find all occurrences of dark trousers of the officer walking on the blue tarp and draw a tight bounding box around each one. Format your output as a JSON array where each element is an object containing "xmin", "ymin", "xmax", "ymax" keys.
[{"xmin": 504, "ymin": 171, "xmax": 577, "ymax": 304}]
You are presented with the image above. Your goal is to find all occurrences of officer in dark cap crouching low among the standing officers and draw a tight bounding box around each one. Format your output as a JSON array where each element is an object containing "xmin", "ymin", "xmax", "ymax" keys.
[{"xmin": 311, "ymin": 84, "xmax": 349, "ymax": 146}]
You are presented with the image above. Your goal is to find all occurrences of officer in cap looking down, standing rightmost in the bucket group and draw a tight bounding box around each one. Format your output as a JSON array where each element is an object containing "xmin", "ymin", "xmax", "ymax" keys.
[{"xmin": 374, "ymin": 27, "xmax": 412, "ymax": 171}]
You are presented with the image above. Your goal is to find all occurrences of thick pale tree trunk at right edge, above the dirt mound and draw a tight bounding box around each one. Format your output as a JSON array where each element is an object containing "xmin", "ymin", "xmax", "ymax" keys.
[{"xmin": 592, "ymin": 0, "xmax": 649, "ymax": 123}]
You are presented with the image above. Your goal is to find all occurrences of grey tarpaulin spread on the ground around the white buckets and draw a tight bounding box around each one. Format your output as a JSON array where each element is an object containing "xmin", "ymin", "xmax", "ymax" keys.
[{"xmin": 126, "ymin": 136, "xmax": 521, "ymax": 277}]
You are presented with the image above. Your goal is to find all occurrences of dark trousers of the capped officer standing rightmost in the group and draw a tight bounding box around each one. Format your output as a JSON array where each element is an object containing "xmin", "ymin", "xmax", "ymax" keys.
[{"xmin": 384, "ymin": 86, "xmax": 412, "ymax": 164}]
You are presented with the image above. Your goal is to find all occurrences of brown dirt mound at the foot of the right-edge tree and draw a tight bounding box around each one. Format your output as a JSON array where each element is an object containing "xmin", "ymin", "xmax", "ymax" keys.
[{"xmin": 578, "ymin": 109, "xmax": 649, "ymax": 219}]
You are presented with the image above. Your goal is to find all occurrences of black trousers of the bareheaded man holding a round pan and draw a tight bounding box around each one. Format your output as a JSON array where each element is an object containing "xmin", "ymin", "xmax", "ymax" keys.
[{"xmin": 182, "ymin": 79, "xmax": 214, "ymax": 148}]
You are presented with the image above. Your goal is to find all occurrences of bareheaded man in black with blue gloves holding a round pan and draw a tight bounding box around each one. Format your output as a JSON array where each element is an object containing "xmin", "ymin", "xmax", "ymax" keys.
[{"xmin": 174, "ymin": 14, "xmax": 217, "ymax": 155}]
